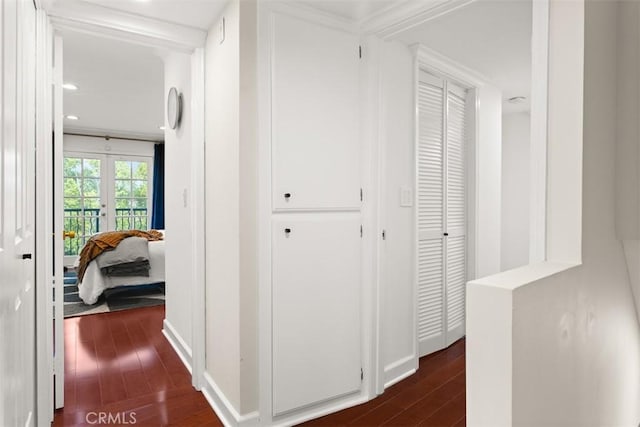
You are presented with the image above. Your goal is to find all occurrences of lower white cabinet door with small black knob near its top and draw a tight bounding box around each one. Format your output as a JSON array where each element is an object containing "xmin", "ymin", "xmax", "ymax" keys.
[{"xmin": 272, "ymin": 213, "xmax": 362, "ymax": 415}]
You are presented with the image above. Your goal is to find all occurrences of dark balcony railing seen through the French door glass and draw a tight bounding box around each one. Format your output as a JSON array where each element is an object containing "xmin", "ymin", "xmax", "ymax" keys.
[{"xmin": 64, "ymin": 208, "xmax": 149, "ymax": 256}]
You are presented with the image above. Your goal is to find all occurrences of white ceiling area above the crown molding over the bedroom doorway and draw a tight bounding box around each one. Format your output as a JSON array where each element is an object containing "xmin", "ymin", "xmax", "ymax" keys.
[{"xmin": 84, "ymin": 0, "xmax": 228, "ymax": 31}]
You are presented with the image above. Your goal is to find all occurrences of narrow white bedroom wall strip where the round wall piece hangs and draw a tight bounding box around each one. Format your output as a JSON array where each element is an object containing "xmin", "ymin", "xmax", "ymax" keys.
[{"xmin": 163, "ymin": 49, "xmax": 195, "ymax": 364}]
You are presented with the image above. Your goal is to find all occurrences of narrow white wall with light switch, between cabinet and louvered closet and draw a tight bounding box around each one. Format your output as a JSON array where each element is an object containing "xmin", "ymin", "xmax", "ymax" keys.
[{"xmin": 380, "ymin": 42, "xmax": 416, "ymax": 383}]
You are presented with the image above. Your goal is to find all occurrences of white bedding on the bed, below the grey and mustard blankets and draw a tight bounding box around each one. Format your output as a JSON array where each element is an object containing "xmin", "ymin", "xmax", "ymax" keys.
[{"xmin": 78, "ymin": 233, "xmax": 165, "ymax": 305}]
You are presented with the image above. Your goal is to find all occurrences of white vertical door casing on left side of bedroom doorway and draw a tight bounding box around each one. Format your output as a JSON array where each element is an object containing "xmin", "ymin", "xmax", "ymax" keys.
[{"xmin": 35, "ymin": 8, "xmax": 54, "ymax": 425}]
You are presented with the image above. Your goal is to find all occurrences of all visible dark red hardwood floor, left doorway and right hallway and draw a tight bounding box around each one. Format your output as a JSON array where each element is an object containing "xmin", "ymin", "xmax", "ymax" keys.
[{"xmin": 53, "ymin": 306, "xmax": 465, "ymax": 427}]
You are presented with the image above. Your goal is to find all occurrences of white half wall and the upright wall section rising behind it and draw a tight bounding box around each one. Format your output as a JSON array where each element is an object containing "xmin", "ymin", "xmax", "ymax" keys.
[{"xmin": 467, "ymin": 1, "xmax": 640, "ymax": 426}]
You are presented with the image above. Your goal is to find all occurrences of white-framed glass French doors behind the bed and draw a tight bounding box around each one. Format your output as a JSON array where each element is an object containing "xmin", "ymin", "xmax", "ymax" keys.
[{"xmin": 63, "ymin": 152, "xmax": 152, "ymax": 265}]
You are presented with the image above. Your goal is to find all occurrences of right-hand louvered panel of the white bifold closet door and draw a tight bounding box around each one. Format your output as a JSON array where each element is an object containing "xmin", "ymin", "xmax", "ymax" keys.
[{"xmin": 445, "ymin": 84, "xmax": 466, "ymax": 346}]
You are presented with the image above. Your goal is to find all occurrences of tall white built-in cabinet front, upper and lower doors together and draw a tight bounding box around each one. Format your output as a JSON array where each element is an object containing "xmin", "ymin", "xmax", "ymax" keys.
[{"xmin": 271, "ymin": 13, "xmax": 362, "ymax": 416}]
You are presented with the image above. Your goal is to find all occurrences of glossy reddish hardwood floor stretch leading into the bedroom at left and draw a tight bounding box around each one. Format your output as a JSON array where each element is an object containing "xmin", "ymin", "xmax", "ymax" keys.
[{"xmin": 53, "ymin": 306, "xmax": 222, "ymax": 427}]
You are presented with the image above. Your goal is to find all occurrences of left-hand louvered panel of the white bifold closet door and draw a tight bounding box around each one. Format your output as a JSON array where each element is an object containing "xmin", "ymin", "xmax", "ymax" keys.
[{"xmin": 417, "ymin": 73, "xmax": 444, "ymax": 355}]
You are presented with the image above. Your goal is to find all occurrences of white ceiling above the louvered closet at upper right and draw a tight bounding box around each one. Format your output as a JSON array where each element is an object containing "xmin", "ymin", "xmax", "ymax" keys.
[{"xmin": 397, "ymin": 0, "xmax": 532, "ymax": 113}]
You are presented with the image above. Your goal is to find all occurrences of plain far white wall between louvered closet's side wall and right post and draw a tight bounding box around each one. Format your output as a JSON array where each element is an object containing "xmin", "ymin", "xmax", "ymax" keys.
[{"xmin": 501, "ymin": 113, "xmax": 531, "ymax": 271}]
